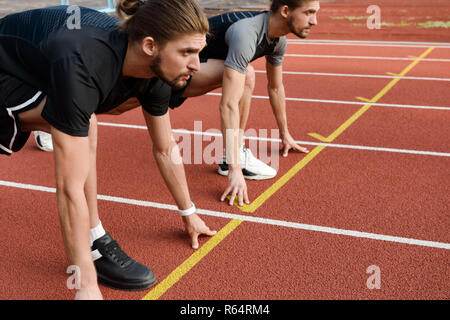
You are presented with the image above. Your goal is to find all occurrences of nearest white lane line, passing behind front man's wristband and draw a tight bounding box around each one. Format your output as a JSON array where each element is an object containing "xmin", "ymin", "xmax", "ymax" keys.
[{"xmin": 0, "ymin": 180, "xmax": 450, "ymax": 250}]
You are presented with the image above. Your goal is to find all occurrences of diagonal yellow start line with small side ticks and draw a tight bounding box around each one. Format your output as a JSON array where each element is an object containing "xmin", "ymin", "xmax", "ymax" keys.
[{"xmin": 142, "ymin": 47, "xmax": 434, "ymax": 300}]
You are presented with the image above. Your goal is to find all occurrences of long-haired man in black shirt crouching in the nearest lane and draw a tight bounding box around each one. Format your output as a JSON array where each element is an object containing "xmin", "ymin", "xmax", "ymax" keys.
[{"xmin": 0, "ymin": 0, "xmax": 215, "ymax": 299}]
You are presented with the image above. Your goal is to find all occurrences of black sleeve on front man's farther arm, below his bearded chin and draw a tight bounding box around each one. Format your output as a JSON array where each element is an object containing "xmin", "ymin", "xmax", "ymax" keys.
[{"xmin": 136, "ymin": 78, "xmax": 172, "ymax": 116}]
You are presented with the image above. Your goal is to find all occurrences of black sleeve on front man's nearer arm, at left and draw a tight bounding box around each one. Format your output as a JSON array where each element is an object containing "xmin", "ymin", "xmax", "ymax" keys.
[{"xmin": 42, "ymin": 57, "xmax": 100, "ymax": 137}]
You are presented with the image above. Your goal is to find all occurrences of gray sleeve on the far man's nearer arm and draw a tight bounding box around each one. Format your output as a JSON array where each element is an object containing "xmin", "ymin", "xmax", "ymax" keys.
[{"xmin": 224, "ymin": 23, "xmax": 257, "ymax": 74}]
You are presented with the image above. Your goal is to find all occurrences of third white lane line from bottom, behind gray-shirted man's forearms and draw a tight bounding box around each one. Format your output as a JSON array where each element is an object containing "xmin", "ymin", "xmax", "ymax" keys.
[{"xmin": 206, "ymin": 92, "xmax": 450, "ymax": 110}]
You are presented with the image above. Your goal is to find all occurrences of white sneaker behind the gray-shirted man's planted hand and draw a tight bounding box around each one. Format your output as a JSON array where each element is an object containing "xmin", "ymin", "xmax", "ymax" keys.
[{"xmin": 218, "ymin": 146, "xmax": 277, "ymax": 180}]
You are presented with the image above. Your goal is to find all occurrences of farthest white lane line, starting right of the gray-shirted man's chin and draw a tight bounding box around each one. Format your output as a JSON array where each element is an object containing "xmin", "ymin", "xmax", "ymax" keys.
[{"xmin": 288, "ymin": 39, "xmax": 450, "ymax": 49}]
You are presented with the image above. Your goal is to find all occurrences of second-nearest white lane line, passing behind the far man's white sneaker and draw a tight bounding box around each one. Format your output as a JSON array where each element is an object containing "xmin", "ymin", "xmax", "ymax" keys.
[{"xmin": 98, "ymin": 122, "xmax": 450, "ymax": 157}]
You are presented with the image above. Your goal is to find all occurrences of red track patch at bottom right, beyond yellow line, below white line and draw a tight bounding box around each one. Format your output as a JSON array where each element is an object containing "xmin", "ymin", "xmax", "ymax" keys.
[{"xmin": 156, "ymin": 223, "xmax": 449, "ymax": 300}]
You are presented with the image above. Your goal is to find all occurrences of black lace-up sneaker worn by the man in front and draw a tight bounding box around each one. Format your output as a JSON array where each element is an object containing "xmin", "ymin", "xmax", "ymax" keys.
[{"xmin": 92, "ymin": 233, "xmax": 156, "ymax": 291}]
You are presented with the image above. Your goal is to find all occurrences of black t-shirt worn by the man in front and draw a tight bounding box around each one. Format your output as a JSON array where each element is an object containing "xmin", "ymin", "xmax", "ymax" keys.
[{"xmin": 0, "ymin": 6, "xmax": 171, "ymax": 136}]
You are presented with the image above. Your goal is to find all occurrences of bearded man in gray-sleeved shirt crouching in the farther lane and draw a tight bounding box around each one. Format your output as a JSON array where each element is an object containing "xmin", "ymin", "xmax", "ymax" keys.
[{"xmin": 170, "ymin": 0, "xmax": 320, "ymax": 206}]
